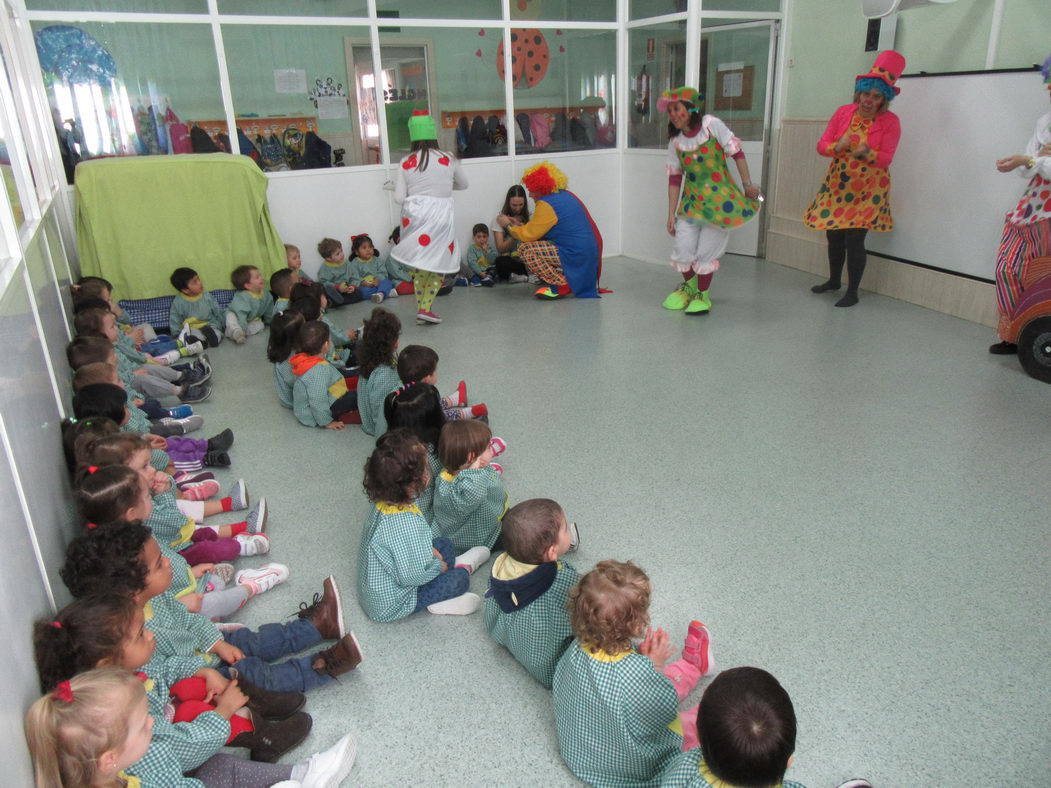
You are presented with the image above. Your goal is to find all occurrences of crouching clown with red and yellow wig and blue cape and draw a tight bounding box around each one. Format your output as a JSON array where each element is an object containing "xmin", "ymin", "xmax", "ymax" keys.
[{"xmin": 496, "ymin": 162, "xmax": 602, "ymax": 299}]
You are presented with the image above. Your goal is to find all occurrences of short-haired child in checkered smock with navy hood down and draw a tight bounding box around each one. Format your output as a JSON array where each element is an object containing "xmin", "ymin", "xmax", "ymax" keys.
[{"xmin": 485, "ymin": 498, "xmax": 579, "ymax": 689}]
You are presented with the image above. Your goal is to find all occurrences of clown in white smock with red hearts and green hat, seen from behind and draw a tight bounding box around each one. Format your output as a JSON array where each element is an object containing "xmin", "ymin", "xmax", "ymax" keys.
[{"xmin": 391, "ymin": 110, "xmax": 467, "ymax": 324}]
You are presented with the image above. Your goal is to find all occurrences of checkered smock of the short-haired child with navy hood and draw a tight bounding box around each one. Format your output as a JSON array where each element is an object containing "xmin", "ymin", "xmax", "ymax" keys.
[{"xmin": 485, "ymin": 561, "xmax": 580, "ymax": 689}]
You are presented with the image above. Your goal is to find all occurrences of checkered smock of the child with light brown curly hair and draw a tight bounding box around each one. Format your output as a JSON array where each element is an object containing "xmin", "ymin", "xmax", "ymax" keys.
[{"xmin": 552, "ymin": 641, "xmax": 682, "ymax": 788}]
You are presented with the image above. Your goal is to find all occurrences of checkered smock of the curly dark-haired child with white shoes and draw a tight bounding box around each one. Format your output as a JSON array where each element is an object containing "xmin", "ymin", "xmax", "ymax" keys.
[{"xmin": 357, "ymin": 502, "xmax": 441, "ymax": 621}]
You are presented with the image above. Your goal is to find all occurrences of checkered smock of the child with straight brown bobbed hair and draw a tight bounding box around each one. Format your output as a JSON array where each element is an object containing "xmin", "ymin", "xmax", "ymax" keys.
[{"xmin": 431, "ymin": 468, "xmax": 508, "ymax": 553}]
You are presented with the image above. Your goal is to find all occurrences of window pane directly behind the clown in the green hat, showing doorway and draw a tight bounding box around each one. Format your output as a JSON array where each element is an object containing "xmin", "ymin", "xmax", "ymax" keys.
[{"xmin": 374, "ymin": 27, "xmax": 508, "ymax": 161}]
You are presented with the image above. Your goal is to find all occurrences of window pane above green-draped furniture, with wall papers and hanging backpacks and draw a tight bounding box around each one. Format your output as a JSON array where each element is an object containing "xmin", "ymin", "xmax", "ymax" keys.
[{"xmin": 218, "ymin": 24, "xmax": 369, "ymax": 172}]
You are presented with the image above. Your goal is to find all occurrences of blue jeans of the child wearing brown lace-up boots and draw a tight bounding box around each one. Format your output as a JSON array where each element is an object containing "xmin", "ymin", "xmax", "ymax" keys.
[{"xmin": 223, "ymin": 619, "xmax": 332, "ymax": 692}]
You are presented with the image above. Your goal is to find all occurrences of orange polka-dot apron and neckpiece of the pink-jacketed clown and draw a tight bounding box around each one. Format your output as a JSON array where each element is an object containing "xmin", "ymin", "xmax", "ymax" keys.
[{"xmin": 803, "ymin": 112, "xmax": 894, "ymax": 232}]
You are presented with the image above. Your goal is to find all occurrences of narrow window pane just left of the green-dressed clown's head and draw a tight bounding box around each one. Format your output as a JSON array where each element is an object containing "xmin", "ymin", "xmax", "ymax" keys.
[{"xmin": 627, "ymin": 22, "xmax": 686, "ymax": 148}]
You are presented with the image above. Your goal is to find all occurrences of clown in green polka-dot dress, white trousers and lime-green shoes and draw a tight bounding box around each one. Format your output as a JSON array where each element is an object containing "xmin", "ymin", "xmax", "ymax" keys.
[{"xmin": 657, "ymin": 86, "xmax": 761, "ymax": 314}]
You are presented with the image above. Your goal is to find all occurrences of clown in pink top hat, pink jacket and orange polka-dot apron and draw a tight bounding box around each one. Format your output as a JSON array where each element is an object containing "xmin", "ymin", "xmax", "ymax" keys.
[{"xmin": 803, "ymin": 49, "xmax": 905, "ymax": 307}]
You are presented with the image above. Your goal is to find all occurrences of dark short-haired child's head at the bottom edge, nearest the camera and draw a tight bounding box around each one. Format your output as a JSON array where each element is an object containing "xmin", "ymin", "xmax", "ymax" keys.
[{"xmin": 697, "ymin": 667, "xmax": 796, "ymax": 788}]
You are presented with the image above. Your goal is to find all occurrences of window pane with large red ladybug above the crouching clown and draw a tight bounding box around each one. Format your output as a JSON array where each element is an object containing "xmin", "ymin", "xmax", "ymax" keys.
[{"xmin": 511, "ymin": 27, "xmax": 617, "ymax": 153}]
